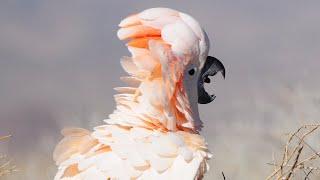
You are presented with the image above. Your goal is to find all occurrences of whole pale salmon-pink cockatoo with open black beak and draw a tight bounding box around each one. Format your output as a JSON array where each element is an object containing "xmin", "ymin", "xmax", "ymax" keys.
[{"xmin": 53, "ymin": 8, "xmax": 225, "ymax": 180}]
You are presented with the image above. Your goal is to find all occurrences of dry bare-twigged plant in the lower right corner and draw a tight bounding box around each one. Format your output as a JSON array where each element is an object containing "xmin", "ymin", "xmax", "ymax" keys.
[{"xmin": 266, "ymin": 124, "xmax": 320, "ymax": 180}]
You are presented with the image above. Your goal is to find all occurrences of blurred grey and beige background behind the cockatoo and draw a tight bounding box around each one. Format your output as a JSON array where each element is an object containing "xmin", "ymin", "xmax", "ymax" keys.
[{"xmin": 0, "ymin": 0, "xmax": 320, "ymax": 180}]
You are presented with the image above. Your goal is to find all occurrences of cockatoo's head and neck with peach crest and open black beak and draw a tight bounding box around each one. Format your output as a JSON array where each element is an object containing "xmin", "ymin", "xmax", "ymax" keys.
[{"xmin": 110, "ymin": 8, "xmax": 225, "ymax": 132}]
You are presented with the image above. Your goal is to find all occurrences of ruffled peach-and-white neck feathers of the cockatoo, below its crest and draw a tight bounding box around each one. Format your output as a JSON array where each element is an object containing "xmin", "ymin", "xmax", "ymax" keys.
[{"xmin": 106, "ymin": 42, "xmax": 202, "ymax": 133}]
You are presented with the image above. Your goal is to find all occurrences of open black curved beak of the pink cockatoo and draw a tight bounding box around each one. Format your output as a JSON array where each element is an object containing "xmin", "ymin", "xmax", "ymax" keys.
[{"xmin": 198, "ymin": 56, "xmax": 226, "ymax": 104}]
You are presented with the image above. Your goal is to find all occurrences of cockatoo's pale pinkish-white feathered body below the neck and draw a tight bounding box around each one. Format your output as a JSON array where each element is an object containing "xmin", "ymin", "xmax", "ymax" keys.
[{"xmin": 56, "ymin": 125, "xmax": 208, "ymax": 180}]
